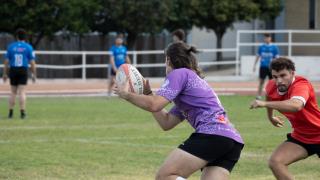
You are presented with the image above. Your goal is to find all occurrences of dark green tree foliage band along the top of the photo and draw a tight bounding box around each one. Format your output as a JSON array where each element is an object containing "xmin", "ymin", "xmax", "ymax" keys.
[{"xmin": 0, "ymin": 0, "xmax": 282, "ymax": 48}]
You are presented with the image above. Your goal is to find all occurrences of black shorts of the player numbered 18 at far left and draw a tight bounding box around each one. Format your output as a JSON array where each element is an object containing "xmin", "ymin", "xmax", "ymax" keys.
[{"xmin": 9, "ymin": 67, "xmax": 28, "ymax": 86}]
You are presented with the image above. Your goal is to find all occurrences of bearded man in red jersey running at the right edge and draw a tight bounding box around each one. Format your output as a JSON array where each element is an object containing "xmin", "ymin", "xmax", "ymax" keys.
[{"xmin": 250, "ymin": 57, "xmax": 320, "ymax": 180}]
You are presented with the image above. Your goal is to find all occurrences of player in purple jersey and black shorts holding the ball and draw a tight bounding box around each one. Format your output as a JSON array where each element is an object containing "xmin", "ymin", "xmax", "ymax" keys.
[{"xmin": 114, "ymin": 42, "xmax": 244, "ymax": 180}]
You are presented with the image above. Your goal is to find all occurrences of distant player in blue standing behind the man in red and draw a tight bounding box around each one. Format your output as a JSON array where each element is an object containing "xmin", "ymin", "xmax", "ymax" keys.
[{"xmin": 253, "ymin": 34, "xmax": 279, "ymax": 99}]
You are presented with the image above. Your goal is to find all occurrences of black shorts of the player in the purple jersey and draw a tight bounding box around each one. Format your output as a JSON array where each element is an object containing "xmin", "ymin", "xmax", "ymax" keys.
[{"xmin": 179, "ymin": 133, "xmax": 244, "ymax": 172}]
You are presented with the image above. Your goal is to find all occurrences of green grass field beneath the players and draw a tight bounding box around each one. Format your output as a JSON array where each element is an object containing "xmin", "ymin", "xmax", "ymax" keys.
[{"xmin": 0, "ymin": 96, "xmax": 320, "ymax": 180}]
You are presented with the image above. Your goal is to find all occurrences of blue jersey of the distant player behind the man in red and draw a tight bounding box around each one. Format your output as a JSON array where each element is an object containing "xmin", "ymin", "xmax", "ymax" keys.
[{"xmin": 258, "ymin": 44, "xmax": 279, "ymax": 67}]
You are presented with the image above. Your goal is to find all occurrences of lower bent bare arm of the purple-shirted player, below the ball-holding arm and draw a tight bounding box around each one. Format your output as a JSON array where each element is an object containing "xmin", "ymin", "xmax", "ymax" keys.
[{"xmin": 152, "ymin": 109, "xmax": 181, "ymax": 131}]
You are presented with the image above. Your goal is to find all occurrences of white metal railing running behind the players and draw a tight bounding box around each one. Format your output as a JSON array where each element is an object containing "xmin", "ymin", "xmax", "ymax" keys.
[{"xmin": 0, "ymin": 30, "xmax": 320, "ymax": 80}]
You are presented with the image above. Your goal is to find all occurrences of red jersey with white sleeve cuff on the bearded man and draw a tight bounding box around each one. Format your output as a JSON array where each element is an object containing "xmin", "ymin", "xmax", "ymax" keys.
[{"xmin": 266, "ymin": 76, "xmax": 320, "ymax": 144}]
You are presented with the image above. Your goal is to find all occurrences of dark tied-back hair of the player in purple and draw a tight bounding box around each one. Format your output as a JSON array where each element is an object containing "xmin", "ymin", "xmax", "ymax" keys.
[{"xmin": 165, "ymin": 42, "xmax": 203, "ymax": 78}]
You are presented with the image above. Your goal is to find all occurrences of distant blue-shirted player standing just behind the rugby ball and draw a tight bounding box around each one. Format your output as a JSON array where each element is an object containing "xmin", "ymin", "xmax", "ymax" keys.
[{"xmin": 108, "ymin": 34, "xmax": 131, "ymax": 96}]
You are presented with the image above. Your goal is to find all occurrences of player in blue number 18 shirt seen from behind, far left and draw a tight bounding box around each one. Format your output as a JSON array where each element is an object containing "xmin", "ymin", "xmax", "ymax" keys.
[{"xmin": 3, "ymin": 29, "xmax": 36, "ymax": 119}]
